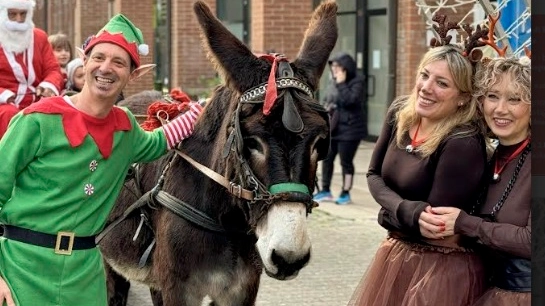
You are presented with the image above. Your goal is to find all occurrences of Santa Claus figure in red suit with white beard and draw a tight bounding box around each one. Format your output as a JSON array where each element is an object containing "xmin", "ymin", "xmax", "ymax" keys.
[{"xmin": 0, "ymin": 0, "xmax": 64, "ymax": 138}]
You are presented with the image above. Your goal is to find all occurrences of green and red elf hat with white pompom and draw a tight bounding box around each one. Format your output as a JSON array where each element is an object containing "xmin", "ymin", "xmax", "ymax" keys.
[{"xmin": 83, "ymin": 13, "xmax": 149, "ymax": 68}]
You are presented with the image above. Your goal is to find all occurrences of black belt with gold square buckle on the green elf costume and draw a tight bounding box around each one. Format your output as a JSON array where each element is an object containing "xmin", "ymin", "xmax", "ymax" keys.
[{"xmin": 3, "ymin": 224, "xmax": 96, "ymax": 255}]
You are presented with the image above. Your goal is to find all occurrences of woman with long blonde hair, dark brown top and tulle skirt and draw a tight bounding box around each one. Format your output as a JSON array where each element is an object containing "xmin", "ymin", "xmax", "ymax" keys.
[{"xmin": 351, "ymin": 44, "xmax": 488, "ymax": 306}]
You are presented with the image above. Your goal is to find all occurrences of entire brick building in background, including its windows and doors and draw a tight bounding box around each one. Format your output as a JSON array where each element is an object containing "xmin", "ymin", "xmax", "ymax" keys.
[{"xmin": 34, "ymin": 0, "xmax": 471, "ymax": 136}]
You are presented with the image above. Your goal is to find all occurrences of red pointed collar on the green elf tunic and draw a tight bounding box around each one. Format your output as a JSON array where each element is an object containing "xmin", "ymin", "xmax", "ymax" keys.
[{"xmin": 23, "ymin": 97, "xmax": 132, "ymax": 159}]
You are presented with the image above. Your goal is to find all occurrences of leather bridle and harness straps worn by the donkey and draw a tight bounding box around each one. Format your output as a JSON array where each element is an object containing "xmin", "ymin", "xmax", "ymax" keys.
[{"xmin": 96, "ymin": 56, "xmax": 326, "ymax": 260}]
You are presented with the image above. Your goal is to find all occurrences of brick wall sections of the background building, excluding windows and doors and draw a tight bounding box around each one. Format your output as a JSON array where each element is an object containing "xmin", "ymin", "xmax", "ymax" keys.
[{"xmin": 30, "ymin": 0, "xmax": 471, "ymax": 104}]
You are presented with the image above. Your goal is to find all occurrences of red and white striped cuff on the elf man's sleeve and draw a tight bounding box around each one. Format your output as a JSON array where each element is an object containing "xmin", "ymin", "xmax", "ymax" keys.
[{"xmin": 163, "ymin": 103, "xmax": 202, "ymax": 150}]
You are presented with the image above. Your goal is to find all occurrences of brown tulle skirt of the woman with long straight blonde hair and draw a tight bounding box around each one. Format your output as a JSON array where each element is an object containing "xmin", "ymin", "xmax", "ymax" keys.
[{"xmin": 349, "ymin": 237, "xmax": 485, "ymax": 306}]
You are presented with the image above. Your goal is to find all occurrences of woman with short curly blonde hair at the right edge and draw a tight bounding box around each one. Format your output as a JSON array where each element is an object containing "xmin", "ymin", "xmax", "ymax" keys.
[{"xmin": 421, "ymin": 57, "xmax": 532, "ymax": 306}]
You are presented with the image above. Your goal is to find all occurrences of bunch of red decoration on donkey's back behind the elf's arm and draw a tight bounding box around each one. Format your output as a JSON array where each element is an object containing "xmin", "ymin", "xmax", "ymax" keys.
[{"xmin": 140, "ymin": 88, "xmax": 191, "ymax": 131}]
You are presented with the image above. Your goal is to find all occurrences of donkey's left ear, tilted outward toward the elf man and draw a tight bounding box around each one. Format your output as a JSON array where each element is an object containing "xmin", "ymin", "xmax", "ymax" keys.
[{"xmin": 193, "ymin": 1, "xmax": 264, "ymax": 92}]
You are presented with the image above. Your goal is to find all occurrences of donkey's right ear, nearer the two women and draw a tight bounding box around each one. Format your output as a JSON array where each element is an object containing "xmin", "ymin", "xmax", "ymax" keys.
[{"xmin": 293, "ymin": 1, "xmax": 338, "ymax": 89}]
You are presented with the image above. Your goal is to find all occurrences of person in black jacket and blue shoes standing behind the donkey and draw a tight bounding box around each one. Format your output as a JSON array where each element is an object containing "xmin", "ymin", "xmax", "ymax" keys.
[{"xmin": 314, "ymin": 52, "xmax": 367, "ymax": 205}]
